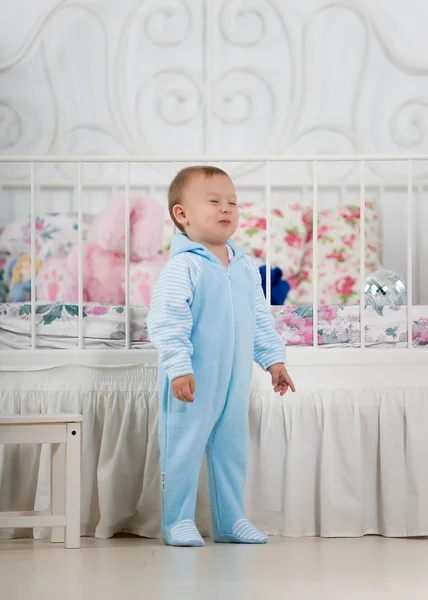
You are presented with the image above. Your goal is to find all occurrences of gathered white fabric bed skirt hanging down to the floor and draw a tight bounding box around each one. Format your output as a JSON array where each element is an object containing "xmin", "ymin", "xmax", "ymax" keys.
[{"xmin": 0, "ymin": 365, "xmax": 428, "ymax": 538}]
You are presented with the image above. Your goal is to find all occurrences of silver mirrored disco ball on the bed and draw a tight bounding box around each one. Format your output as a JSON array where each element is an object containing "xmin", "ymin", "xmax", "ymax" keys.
[{"xmin": 364, "ymin": 269, "xmax": 407, "ymax": 308}]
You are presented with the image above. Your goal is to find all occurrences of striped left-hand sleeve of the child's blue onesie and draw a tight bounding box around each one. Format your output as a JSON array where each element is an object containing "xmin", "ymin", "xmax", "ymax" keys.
[{"xmin": 147, "ymin": 255, "xmax": 198, "ymax": 381}]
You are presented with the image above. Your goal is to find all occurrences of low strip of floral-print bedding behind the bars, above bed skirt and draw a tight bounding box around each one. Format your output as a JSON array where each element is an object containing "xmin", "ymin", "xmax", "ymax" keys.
[{"xmin": 0, "ymin": 303, "xmax": 428, "ymax": 350}]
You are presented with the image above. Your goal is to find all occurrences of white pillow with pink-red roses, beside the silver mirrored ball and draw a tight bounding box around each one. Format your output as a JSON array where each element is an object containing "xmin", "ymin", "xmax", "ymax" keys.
[{"xmin": 287, "ymin": 201, "xmax": 381, "ymax": 305}]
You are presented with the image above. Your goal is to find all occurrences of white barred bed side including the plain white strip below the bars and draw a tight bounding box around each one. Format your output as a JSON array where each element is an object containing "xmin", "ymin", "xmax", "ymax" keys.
[{"xmin": 0, "ymin": 155, "xmax": 428, "ymax": 381}]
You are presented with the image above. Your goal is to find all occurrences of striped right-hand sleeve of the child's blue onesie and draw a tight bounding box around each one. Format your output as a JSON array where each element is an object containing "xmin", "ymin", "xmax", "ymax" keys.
[{"xmin": 248, "ymin": 259, "xmax": 285, "ymax": 369}]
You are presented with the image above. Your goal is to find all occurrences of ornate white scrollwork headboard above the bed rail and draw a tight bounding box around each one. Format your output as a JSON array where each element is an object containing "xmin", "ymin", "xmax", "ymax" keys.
[{"xmin": 0, "ymin": 0, "xmax": 428, "ymax": 179}]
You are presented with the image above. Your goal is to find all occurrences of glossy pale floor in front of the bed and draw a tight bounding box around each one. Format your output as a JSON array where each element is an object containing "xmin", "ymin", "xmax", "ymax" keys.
[{"xmin": 0, "ymin": 537, "xmax": 428, "ymax": 600}]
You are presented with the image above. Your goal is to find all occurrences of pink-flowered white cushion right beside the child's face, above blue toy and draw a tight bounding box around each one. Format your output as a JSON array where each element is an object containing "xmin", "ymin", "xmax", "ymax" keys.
[{"xmin": 233, "ymin": 204, "xmax": 307, "ymax": 279}]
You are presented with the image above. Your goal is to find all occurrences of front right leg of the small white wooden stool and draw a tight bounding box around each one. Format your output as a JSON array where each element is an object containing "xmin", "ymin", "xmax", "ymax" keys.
[{"xmin": 65, "ymin": 423, "xmax": 81, "ymax": 548}]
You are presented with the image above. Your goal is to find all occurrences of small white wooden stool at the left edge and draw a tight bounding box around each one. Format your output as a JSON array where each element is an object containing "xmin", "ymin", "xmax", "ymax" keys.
[{"xmin": 0, "ymin": 414, "xmax": 82, "ymax": 548}]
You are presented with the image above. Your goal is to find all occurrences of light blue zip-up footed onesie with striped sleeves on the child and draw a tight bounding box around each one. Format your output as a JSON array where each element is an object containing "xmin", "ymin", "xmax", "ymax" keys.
[{"xmin": 148, "ymin": 234, "xmax": 285, "ymax": 546}]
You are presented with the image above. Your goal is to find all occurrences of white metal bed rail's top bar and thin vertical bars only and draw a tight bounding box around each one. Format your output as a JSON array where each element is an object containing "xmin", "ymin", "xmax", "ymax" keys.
[{"xmin": 0, "ymin": 154, "xmax": 428, "ymax": 362}]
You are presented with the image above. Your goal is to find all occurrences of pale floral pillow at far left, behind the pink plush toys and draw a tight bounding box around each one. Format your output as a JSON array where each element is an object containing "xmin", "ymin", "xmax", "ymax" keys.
[{"xmin": 0, "ymin": 213, "xmax": 93, "ymax": 281}]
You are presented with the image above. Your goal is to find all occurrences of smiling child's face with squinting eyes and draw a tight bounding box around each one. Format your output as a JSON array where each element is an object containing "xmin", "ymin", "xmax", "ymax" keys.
[{"xmin": 177, "ymin": 174, "xmax": 239, "ymax": 244}]
